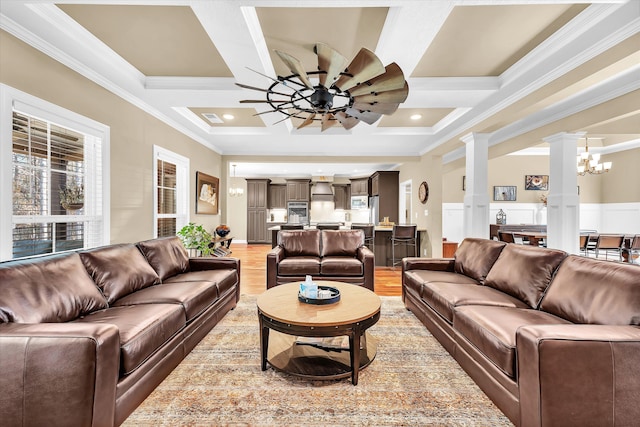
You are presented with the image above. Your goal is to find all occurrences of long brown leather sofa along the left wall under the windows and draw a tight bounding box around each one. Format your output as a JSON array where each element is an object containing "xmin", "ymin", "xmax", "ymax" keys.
[{"xmin": 0, "ymin": 237, "xmax": 240, "ymax": 426}]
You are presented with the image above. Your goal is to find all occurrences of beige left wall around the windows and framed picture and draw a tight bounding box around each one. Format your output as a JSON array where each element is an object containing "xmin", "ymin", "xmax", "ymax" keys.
[{"xmin": 0, "ymin": 32, "xmax": 224, "ymax": 243}]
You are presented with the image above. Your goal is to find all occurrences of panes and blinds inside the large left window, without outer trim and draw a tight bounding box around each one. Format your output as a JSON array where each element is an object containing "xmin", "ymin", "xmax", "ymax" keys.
[{"xmin": 11, "ymin": 109, "xmax": 105, "ymax": 258}]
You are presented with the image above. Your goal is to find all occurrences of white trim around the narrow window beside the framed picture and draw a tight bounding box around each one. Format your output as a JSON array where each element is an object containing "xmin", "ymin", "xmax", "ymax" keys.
[{"xmin": 153, "ymin": 144, "xmax": 190, "ymax": 239}]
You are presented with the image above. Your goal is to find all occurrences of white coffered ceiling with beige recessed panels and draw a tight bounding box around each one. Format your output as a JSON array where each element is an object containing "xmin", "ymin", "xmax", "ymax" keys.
[{"xmin": 0, "ymin": 0, "xmax": 640, "ymax": 176}]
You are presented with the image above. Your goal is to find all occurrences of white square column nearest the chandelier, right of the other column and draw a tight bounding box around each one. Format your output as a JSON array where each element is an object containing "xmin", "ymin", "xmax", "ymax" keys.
[{"xmin": 543, "ymin": 132, "xmax": 584, "ymax": 254}]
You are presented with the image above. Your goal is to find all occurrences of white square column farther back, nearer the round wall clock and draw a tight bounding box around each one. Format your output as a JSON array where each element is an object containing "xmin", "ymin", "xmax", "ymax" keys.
[{"xmin": 461, "ymin": 133, "xmax": 489, "ymax": 238}]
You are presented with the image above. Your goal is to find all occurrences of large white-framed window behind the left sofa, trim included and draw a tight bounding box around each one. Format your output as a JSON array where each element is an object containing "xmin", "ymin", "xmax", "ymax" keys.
[{"xmin": 0, "ymin": 86, "xmax": 109, "ymax": 260}]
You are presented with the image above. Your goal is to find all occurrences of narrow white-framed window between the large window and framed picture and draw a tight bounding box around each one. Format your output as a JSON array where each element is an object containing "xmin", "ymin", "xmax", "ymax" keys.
[{"xmin": 153, "ymin": 146, "xmax": 189, "ymax": 237}]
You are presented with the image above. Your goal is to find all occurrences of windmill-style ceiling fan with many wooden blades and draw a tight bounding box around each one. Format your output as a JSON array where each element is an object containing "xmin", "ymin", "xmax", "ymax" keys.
[{"xmin": 236, "ymin": 43, "xmax": 409, "ymax": 131}]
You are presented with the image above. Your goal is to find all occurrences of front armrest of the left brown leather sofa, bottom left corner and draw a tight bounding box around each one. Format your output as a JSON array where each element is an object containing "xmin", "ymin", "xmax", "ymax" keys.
[{"xmin": 0, "ymin": 323, "xmax": 120, "ymax": 426}]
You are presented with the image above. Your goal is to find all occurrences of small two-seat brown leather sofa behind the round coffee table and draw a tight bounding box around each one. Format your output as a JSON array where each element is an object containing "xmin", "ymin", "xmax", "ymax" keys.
[{"xmin": 267, "ymin": 230, "xmax": 375, "ymax": 291}]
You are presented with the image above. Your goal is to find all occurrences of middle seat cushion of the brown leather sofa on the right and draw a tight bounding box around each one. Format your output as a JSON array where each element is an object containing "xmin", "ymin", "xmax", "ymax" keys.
[{"xmin": 420, "ymin": 282, "xmax": 527, "ymax": 323}]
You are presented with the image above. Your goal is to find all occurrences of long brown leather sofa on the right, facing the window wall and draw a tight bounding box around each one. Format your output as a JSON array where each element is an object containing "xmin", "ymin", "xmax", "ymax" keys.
[{"xmin": 402, "ymin": 239, "xmax": 640, "ymax": 427}]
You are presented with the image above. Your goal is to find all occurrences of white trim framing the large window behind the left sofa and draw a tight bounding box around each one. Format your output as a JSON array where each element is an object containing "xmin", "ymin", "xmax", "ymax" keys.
[{"xmin": 0, "ymin": 83, "xmax": 111, "ymax": 261}]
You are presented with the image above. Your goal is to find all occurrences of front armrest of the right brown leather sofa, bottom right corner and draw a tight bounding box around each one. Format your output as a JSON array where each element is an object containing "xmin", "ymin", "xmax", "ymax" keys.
[{"xmin": 516, "ymin": 324, "xmax": 640, "ymax": 427}]
